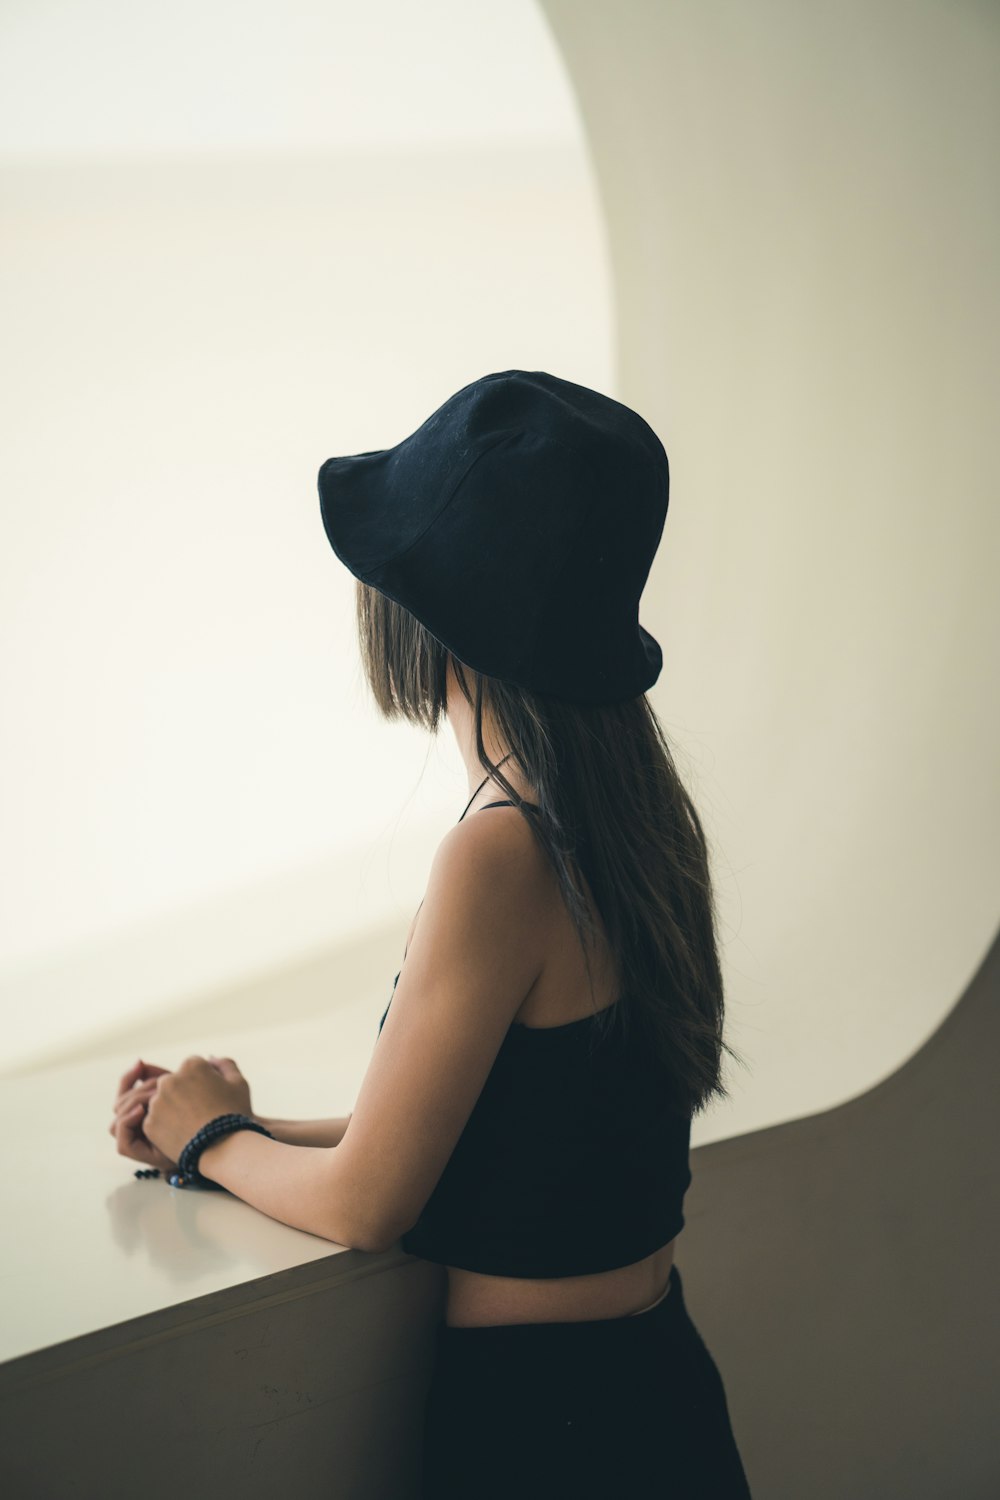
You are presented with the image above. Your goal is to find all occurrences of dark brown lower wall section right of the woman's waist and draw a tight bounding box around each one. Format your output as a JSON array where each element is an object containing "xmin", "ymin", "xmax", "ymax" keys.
[{"xmin": 678, "ymin": 938, "xmax": 1000, "ymax": 1500}]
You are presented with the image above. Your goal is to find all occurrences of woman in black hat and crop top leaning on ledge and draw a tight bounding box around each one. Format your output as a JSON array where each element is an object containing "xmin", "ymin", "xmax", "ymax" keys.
[{"xmin": 112, "ymin": 371, "xmax": 750, "ymax": 1500}]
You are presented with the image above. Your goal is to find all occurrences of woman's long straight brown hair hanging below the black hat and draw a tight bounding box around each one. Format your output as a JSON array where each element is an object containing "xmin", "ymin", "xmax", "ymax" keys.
[{"xmin": 355, "ymin": 579, "xmax": 744, "ymax": 1116}]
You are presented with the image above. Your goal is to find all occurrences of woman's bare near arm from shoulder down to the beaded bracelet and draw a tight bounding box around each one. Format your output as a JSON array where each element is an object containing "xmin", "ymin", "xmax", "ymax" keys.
[{"xmin": 189, "ymin": 815, "xmax": 552, "ymax": 1253}]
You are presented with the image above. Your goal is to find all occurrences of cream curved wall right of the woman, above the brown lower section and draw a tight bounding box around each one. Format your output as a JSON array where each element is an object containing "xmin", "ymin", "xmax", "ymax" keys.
[{"xmin": 543, "ymin": 0, "xmax": 1000, "ymax": 1142}]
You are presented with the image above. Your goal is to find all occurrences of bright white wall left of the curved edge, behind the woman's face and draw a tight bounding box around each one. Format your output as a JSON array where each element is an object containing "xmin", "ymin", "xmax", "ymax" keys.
[{"xmin": 0, "ymin": 0, "xmax": 612, "ymax": 1067}]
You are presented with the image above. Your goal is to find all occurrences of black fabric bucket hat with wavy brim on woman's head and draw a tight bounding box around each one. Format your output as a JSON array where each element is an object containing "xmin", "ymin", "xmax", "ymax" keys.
[{"xmin": 319, "ymin": 371, "xmax": 670, "ymax": 704}]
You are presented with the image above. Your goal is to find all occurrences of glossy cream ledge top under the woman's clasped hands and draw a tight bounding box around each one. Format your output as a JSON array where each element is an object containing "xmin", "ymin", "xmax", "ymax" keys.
[{"xmin": 0, "ymin": 978, "xmax": 406, "ymax": 1362}]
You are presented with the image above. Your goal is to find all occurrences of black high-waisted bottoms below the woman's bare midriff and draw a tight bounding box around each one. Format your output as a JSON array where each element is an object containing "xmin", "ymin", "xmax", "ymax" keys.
[{"xmin": 421, "ymin": 1266, "xmax": 750, "ymax": 1500}]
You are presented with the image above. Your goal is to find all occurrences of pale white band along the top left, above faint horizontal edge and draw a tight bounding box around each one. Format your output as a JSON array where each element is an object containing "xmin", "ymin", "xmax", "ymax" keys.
[{"xmin": 0, "ymin": 0, "xmax": 579, "ymax": 159}]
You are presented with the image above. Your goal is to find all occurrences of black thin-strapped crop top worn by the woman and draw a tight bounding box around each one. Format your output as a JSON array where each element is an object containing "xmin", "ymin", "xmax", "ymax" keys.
[{"xmin": 371, "ymin": 803, "xmax": 691, "ymax": 1278}]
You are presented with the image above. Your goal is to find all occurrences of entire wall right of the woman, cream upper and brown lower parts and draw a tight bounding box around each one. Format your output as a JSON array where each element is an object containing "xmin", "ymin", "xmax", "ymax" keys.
[{"xmin": 541, "ymin": 0, "xmax": 1000, "ymax": 1500}]
